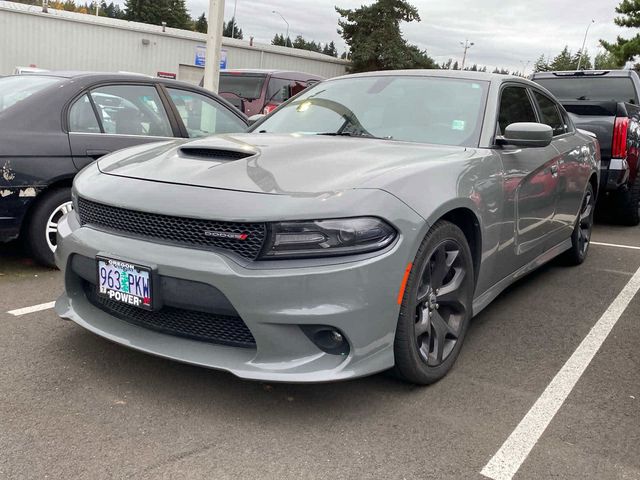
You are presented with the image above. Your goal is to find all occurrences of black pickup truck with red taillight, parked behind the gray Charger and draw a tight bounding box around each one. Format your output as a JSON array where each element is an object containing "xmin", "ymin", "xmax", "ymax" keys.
[{"xmin": 533, "ymin": 70, "xmax": 640, "ymax": 226}]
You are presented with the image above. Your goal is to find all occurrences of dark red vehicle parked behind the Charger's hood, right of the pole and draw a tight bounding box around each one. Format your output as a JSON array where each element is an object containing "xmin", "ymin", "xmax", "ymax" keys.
[{"xmin": 200, "ymin": 70, "xmax": 324, "ymax": 117}]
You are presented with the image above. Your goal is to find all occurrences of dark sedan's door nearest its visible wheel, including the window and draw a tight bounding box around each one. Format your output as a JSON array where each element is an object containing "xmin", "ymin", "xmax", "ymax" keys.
[{"xmin": 67, "ymin": 84, "xmax": 180, "ymax": 169}]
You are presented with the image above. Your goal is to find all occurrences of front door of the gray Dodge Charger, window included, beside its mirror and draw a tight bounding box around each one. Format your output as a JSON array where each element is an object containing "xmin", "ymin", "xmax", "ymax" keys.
[{"xmin": 497, "ymin": 84, "xmax": 558, "ymax": 268}]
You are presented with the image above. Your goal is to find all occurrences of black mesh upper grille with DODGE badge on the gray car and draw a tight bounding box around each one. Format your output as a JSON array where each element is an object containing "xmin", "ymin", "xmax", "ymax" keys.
[{"xmin": 78, "ymin": 198, "xmax": 266, "ymax": 260}]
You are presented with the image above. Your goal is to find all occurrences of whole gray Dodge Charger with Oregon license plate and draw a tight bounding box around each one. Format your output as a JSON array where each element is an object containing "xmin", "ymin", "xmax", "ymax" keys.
[{"xmin": 56, "ymin": 71, "xmax": 600, "ymax": 384}]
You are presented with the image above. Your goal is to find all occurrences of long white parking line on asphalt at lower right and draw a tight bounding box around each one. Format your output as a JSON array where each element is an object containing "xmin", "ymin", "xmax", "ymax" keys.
[{"xmin": 480, "ymin": 269, "xmax": 640, "ymax": 480}]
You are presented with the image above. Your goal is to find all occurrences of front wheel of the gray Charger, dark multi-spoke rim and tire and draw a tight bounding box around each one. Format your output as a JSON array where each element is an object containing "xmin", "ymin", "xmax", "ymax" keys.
[{"xmin": 394, "ymin": 221, "xmax": 475, "ymax": 385}]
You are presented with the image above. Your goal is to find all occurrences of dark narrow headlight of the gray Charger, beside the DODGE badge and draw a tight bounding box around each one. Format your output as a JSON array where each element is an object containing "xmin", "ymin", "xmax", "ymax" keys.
[{"xmin": 261, "ymin": 217, "xmax": 397, "ymax": 259}]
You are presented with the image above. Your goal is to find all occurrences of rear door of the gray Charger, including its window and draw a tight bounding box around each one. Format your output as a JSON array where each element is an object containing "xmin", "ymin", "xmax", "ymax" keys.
[{"xmin": 533, "ymin": 89, "xmax": 591, "ymax": 239}]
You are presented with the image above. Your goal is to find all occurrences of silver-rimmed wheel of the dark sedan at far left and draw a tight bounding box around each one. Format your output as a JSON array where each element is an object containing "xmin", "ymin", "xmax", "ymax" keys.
[{"xmin": 25, "ymin": 188, "xmax": 72, "ymax": 268}]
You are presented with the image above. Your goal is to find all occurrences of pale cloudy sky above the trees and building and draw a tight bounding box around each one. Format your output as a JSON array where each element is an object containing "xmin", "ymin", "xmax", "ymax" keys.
[{"xmin": 121, "ymin": 0, "xmax": 635, "ymax": 73}]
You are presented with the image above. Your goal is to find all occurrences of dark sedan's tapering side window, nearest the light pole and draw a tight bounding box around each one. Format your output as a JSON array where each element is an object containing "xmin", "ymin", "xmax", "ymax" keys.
[{"xmin": 167, "ymin": 88, "xmax": 247, "ymax": 138}]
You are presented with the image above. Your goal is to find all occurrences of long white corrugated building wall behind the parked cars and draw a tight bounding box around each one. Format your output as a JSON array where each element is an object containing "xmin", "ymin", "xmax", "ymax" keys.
[{"xmin": 0, "ymin": 0, "xmax": 348, "ymax": 78}]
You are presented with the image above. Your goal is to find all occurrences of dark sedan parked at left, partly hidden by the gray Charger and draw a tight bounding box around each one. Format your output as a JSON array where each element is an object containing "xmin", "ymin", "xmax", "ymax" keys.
[{"xmin": 0, "ymin": 73, "xmax": 248, "ymax": 266}]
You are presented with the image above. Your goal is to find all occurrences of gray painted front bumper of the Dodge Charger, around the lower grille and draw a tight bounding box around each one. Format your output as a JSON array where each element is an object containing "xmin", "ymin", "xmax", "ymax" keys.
[{"xmin": 56, "ymin": 188, "xmax": 426, "ymax": 382}]
